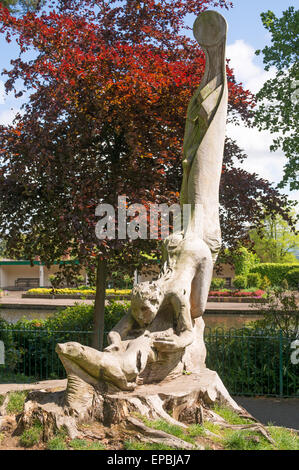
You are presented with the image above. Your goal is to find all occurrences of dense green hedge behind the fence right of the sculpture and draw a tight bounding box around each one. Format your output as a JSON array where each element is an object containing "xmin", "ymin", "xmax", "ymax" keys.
[{"xmin": 205, "ymin": 323, "xmax": 299, "ymax": 396}]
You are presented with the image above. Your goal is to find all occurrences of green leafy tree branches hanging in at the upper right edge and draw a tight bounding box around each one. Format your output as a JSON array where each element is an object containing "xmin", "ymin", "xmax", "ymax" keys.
[{"xmin": 255, "ymin": 7, "xmax": 299, "ymax": 190}]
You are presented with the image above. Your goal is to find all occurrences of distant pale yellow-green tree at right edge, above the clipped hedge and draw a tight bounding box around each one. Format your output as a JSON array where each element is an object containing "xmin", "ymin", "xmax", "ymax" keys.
[{"xmin": 249, "ymin": 215, "xmax": 299, "ymax": 263}]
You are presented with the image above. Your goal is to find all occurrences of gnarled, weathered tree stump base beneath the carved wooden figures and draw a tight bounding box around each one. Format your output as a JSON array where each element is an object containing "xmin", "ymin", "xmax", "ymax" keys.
[{"xmin": 17, "ymin": 369, "xmax": 251, "ymax": 441}]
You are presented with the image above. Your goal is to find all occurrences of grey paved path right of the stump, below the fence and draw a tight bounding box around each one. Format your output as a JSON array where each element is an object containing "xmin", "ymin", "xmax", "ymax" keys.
[{"xmin": 234, "ymin": 397, "xmax": 299, "ymax": 430}]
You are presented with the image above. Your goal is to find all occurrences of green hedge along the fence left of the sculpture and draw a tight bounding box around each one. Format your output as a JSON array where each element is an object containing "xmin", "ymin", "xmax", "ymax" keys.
[{"xmin": 0, "ymin": 302, "xmax": 129, "ymax": 380}]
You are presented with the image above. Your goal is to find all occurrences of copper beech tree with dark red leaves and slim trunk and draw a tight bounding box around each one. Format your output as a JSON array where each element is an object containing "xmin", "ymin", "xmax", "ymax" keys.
[{"xmin": 0, "ymin": 0, "xmax": 296, "ymax": 347}]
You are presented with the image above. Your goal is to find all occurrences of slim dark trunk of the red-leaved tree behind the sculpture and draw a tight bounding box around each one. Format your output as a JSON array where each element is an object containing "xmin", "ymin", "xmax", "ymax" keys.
[{"xmin": 92, "ymin": 257, "xmax": 107, "ymax": 351}]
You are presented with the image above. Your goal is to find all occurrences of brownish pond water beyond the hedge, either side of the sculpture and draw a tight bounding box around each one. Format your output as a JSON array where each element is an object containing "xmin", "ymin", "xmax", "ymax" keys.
[{"xmin": 0, "ymin": 308, "xmax": 261, "ymax": 329}]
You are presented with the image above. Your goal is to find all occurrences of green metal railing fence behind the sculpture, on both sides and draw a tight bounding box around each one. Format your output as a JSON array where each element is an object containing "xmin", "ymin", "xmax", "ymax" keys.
[{"xmin": 0, "ymin": 327, "xmax": 299, "ymax": 397}]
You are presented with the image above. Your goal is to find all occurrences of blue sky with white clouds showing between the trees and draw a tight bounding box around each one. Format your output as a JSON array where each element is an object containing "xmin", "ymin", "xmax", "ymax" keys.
[{"xmin": 0, "ymin": 0, "xmax": 299, "ymax": 206}]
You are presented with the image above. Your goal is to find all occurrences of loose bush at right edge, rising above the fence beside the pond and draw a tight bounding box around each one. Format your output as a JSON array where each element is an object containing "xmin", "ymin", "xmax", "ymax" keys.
[{"xmin": 256, "ymin": 287, "xmax": 299, "ymax": 336}]
